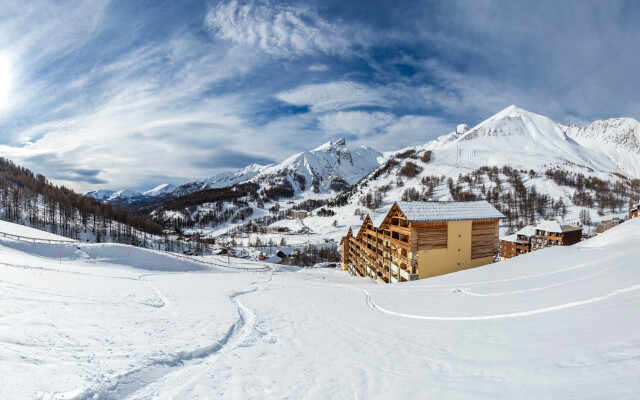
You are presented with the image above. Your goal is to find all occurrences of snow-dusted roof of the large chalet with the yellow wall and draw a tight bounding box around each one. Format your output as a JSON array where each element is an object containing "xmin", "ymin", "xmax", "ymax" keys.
[{"xmin": 397, "ymin": 200, "xmax": 504, "ymax": 222}]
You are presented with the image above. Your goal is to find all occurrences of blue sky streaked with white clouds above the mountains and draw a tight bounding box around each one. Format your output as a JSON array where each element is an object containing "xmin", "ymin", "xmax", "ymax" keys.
[{"xmin": 0, "ymin": 0, "xmax": 640, "ymax": 191}]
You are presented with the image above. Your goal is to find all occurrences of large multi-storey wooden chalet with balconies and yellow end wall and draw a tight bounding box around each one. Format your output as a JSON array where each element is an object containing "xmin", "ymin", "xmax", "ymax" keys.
[{"xmin": 340, "ymin": 201, "xmax": 504, "ymax": 283}]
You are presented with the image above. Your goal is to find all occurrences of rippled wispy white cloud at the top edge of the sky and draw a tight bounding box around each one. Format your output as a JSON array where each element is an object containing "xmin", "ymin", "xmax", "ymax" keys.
[{"xmin": 205, "ymin": 0, "xmax": 350, "ymax": 57}]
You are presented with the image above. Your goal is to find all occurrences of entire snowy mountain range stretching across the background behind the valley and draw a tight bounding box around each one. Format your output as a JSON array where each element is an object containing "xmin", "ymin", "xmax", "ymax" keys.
[{"xmin": 85, "ymin": 106, "xmax": 640, "ymax": 237}]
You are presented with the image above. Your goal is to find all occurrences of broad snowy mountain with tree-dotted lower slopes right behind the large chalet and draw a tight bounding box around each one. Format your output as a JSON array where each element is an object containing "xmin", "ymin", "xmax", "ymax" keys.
[{"xmin": 324, "ymin": 106, "xmax": 640, "ymax": 239}]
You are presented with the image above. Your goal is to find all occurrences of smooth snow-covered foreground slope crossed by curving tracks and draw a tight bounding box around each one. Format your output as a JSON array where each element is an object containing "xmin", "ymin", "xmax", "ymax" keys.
[{"xmin": 0, "ymin": 219, "xmax": 640, "ymax": 399}]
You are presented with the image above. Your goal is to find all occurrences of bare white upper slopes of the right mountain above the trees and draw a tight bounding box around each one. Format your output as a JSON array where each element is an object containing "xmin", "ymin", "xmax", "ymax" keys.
[{"xmin": 416, "ymin": 106, "xmax": 640, "ymax": 177}]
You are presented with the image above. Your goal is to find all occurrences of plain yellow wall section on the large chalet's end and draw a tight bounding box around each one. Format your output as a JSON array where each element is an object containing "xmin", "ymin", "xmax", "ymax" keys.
[{"xmin": 418, "ymin": 221, "xmax": 493, "ymax": 279}]
